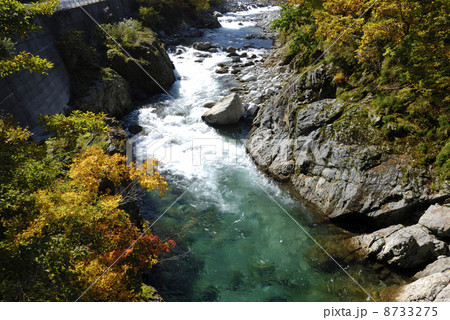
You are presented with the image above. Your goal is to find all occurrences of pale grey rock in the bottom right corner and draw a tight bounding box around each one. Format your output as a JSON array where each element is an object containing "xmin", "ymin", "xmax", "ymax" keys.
[{"xmin": 395, "ymin": 271, "xmax": 450, "ymax": 302}]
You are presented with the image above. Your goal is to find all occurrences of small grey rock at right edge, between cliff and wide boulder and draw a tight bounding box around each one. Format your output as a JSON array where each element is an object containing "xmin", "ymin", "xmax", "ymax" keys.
[{"xmin": 419, "ymin": 205, "xmax": 450, "ymax": 238}]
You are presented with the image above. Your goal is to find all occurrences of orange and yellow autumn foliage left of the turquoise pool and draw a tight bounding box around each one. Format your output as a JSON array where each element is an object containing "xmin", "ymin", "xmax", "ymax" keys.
[{"xmin": 0, "ymin": 113, "xmax": 175, "ymax": 301}]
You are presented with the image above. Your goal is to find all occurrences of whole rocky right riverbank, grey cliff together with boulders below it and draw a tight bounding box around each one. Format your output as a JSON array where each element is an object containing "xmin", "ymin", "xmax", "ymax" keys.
[{"xmin": 237, "ymin": 3, "xmax": 450, "ymax": 301}]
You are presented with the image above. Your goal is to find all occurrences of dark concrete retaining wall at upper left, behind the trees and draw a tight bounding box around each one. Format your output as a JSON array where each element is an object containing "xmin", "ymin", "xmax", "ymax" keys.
[{"xmin": 0, "ymin": 0, "xmax": 136, "ymax": 128}]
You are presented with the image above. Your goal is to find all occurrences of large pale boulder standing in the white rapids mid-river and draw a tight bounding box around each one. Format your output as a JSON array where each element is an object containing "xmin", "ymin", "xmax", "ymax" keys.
[{"xmin": 202, "ymin": 93, "xmax": 245, "ymax": 125}]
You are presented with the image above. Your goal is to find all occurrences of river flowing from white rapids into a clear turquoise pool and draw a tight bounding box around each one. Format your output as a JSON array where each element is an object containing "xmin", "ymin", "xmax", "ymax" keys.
[{"xmin": 122, "ymin": 8, "xmax": 404, "ymax": 301}]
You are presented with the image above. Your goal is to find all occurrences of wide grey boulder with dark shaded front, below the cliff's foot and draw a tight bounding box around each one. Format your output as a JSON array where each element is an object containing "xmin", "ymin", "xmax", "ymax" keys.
[{"xmin": 351, "ymin": 224, "xmax": 448, "ymax": 269}]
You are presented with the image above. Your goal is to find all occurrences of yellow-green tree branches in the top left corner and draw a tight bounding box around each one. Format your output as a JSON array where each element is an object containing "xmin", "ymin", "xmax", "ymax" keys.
[{"xmin": 0, "ymin": 0, "xmax": 59, "ymax": 77}]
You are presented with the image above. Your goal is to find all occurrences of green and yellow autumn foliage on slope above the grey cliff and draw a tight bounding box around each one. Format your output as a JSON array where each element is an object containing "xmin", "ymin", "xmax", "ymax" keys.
[{"xmin": 273, "ymin": 0, "xmax": 450, "ymax": 184}]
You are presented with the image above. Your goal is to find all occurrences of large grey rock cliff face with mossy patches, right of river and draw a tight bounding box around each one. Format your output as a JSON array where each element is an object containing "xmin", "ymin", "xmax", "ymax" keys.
[{"xmin": 247, "ymin": 66, "xmax": 446, "ymax": 225}]
